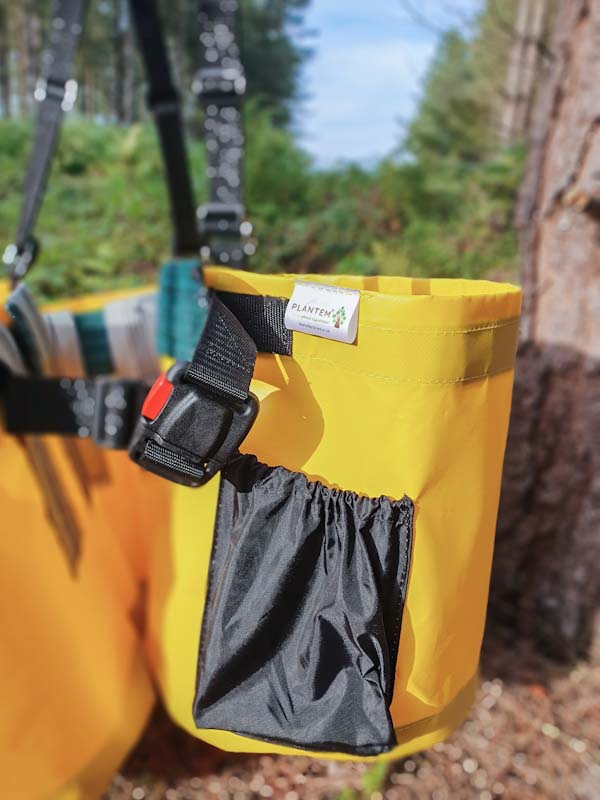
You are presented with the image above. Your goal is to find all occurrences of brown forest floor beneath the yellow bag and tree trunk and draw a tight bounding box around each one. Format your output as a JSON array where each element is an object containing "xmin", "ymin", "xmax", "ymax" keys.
[{"xmin": 104, "ymin": 626, "xmax": 600, "ymax": 800}]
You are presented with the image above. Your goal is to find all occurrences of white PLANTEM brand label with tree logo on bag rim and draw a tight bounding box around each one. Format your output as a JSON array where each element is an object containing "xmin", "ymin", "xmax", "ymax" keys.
[{"xmin": 285, "ymin": 281, "xmax": 360, "ymax": 344}]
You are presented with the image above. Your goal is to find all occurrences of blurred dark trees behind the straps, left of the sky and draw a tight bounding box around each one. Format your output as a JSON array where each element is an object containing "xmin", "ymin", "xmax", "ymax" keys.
[{"xmin": 0, "ymin": 0, "xmax": 310, "ymax": 125}]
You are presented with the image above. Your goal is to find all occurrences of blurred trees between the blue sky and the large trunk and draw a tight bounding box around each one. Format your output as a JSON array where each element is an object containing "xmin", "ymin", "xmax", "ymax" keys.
[{"xmin": 406, "ymin": 0, "xmax": 556, "ymax": 164}]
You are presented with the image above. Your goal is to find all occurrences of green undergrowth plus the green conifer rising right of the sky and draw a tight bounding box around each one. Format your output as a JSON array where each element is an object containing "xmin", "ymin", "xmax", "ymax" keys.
[{"xmin": 0, "ymin": 0, "xmax": 523, "ymax": 298}]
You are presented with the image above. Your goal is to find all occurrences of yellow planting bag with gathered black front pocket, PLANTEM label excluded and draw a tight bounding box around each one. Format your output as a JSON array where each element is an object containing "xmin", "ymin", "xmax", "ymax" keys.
[{"xmin": 148, "ymin": 268, "xmax": 521, "ymax": 759}]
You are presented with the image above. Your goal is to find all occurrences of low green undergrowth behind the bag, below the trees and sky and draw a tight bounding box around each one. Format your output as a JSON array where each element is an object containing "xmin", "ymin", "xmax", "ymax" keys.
[{"xmin": 0, "ymin": 111, "xmax": 521, "ymax": 297}]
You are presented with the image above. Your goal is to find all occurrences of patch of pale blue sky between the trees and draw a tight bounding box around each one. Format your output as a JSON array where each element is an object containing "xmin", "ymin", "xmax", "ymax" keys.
[{"xmin": 296, "ymin": 0, "xmax": 480, "ymax": 166}]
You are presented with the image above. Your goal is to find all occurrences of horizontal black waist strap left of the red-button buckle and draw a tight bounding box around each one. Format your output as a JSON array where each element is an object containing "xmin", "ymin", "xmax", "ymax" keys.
[{"xmin": 3, "ymin": 374, "xmax": 148, "ymax": 449}]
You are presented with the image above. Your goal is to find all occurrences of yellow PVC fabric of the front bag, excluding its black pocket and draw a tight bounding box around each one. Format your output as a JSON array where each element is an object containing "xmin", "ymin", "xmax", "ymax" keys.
[{"xmin": 149, "ymin": 268, "xmax": 521, "ymax": 760}]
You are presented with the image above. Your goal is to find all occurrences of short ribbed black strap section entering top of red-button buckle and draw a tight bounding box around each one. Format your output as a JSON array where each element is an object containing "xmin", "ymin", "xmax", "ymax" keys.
[{"xmin": 185, "ymin": 293, "xmax": 256, "ymax": 400}]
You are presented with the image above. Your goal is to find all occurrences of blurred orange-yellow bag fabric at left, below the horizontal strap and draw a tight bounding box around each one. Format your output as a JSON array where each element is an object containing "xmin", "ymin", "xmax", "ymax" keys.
[{"xmin": 0, "ymin": 284, "xmax": 169, "ymax": 800}]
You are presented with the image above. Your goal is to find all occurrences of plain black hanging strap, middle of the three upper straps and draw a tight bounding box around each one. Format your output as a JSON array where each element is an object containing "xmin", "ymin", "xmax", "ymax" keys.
[{"xmin": 129, "ymin": 0, "xmax": 201, "ymax": 255}]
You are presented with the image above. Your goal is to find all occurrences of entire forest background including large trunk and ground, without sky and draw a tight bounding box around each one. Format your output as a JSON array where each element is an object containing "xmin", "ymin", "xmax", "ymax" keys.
[{"xmin": 0, "ymin": 0, "xmax": 600, "ymax": 800}]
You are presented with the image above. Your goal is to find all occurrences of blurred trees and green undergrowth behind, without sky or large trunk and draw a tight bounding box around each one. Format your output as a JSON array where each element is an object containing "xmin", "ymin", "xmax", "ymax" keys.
[{"xmin": 0, "ymin": 0, "xmax": 532, "ymax": 298}]
